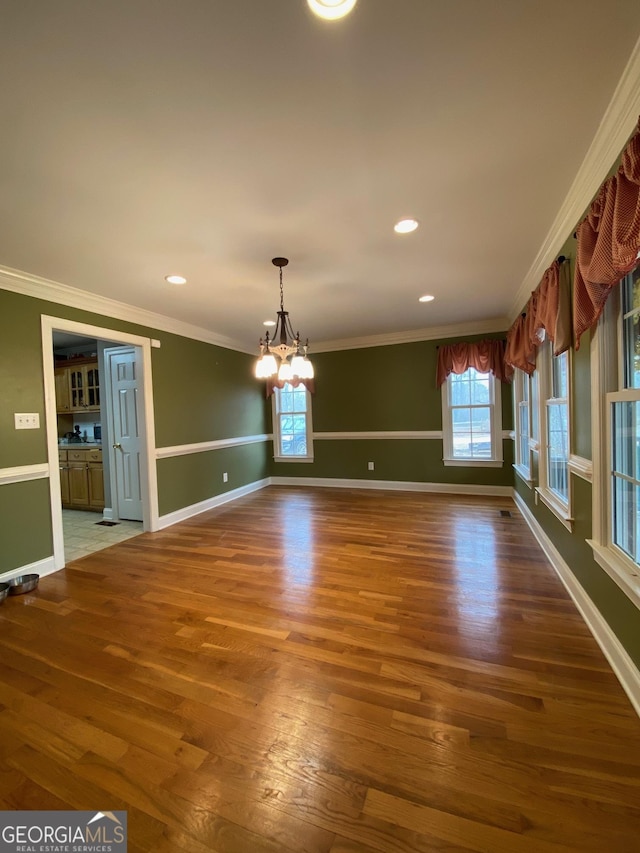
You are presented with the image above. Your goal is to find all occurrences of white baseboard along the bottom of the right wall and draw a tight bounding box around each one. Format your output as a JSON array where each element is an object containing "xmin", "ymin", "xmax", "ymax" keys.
[{"xmin": 513, "ymin": 490, "xmax": 640, "ymax": 716}]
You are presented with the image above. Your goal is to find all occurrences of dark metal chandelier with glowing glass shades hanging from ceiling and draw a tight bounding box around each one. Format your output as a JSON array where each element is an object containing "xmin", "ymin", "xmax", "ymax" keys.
[{"xmin": 256, "ymin": 258, "xmax": 313, "ymax": 386}]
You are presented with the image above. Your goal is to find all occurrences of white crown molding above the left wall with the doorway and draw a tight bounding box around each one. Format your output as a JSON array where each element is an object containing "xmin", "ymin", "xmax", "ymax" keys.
[{"xmin": 0, "ymin": 266, "xmax": 252, "ymax": 353}]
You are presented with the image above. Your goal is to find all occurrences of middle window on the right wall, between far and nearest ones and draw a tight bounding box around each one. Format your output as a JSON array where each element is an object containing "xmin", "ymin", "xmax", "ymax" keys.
[{"xmin": 538, "ymin": 341, "xmax": 572, "ymax": 528}]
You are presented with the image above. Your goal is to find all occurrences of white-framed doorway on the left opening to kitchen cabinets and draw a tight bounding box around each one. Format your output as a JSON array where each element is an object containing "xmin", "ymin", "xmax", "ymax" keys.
[{"xmin": 42, "ymin": 316, "xmax": 158, "ymax": 568}]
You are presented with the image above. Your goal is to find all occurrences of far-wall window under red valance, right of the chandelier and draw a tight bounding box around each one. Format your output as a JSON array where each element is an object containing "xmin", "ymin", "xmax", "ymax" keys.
[{"xmin": 442, "ymin": 367, "xmax": 502, "ymax": 466}]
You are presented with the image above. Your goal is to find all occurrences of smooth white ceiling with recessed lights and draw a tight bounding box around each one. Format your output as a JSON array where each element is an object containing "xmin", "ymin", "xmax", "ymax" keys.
[{"xmin": 0, "ymin": 0, "xmax": 640, "ymax": 351}]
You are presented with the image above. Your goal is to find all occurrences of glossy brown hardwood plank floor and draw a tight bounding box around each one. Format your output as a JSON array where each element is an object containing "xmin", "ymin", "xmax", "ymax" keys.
[{"xmin": 0, "ymin": 487, "xmax": 640, "ymax": 853}]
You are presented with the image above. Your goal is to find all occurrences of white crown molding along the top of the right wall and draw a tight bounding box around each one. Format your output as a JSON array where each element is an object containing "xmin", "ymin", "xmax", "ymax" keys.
[{"xmin": 508, "ymin": 32, "xmax": 640, "ymax": 326}]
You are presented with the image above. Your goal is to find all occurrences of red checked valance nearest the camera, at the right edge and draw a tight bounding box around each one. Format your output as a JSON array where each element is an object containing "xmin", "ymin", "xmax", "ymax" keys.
[{"xmin": 573, "ymin": 117, "xmax": 640, "ymax": 349}]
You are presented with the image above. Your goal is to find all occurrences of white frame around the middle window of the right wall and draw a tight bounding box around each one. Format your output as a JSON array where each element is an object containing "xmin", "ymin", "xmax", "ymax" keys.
[{"xmin": 536, "ymin": 341, "xmax": 574, "ymax": 531}]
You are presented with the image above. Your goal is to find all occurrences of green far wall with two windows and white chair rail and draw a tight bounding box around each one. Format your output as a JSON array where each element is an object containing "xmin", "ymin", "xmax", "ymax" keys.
[{"xmin": 269, "ymin": 334, "xmax": 513, "ymax": 486}]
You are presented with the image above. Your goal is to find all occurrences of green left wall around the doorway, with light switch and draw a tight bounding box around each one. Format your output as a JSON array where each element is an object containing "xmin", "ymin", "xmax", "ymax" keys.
[{"xmin": 0, "ymin": 290, "xmax": 268, "ymax": 574}]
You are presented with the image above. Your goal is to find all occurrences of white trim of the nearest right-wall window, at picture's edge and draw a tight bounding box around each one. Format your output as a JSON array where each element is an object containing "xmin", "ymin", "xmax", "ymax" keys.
[{"xmin": 587, "ymin": 287, "xmax": 640, "ymax": 609}]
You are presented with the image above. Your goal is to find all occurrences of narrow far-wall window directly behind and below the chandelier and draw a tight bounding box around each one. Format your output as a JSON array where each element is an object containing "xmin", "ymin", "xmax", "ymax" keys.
[{"xmin": 273, "ymin": 382, "xmax": 313, "ymax": 462}]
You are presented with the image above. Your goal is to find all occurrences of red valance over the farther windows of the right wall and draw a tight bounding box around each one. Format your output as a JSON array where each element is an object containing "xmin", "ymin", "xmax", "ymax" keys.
[{"xmin": 505, "ymin": 258, "xmax": 571, "ymax": 375}]
